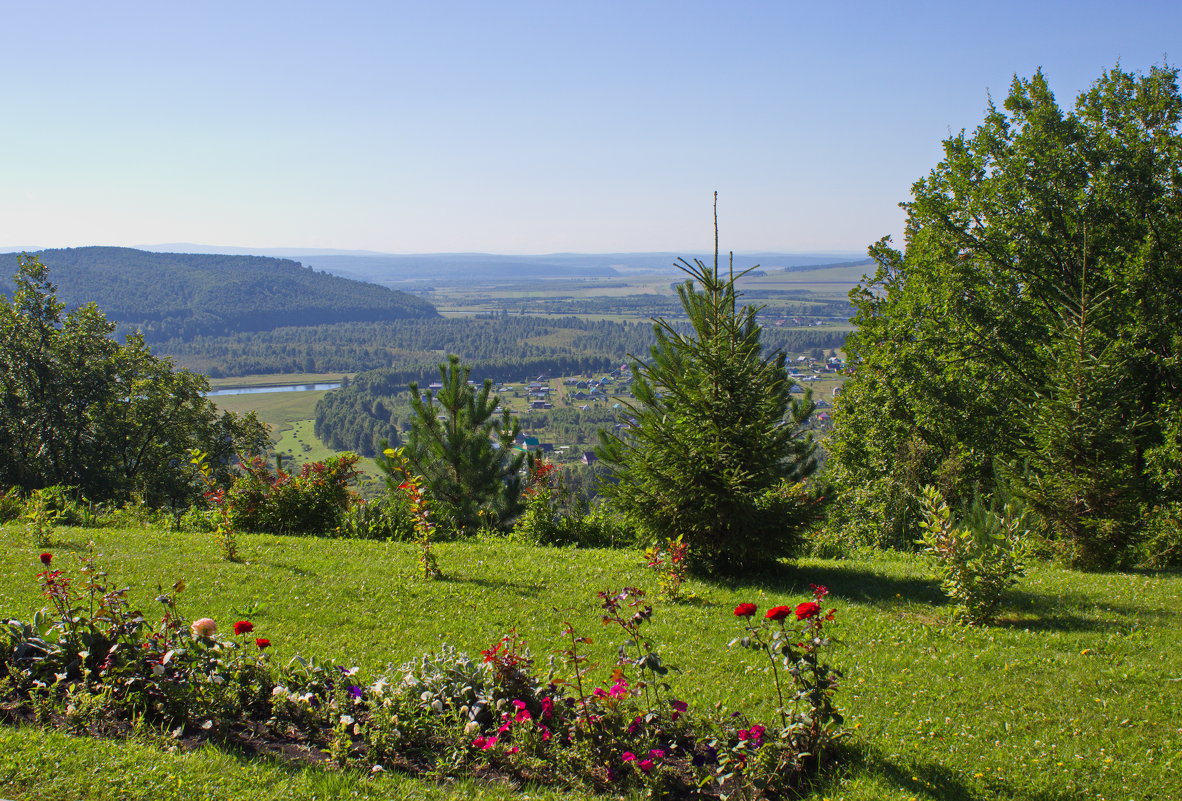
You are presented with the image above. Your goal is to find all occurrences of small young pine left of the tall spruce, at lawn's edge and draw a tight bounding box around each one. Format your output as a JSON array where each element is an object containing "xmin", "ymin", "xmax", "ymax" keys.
[{"xmin": 378, "ymin": 356, "xmax": 526, "ymax": 533}]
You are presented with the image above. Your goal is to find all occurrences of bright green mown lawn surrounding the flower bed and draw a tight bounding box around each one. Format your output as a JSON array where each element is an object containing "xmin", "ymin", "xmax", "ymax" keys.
[{"xmin": 0, "ymin": 525, "xmax": 1182, "ymax": 801}]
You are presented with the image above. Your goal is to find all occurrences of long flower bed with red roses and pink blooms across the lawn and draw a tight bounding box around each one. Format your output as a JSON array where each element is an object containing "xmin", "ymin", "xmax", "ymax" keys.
[{"xmin": 0, "ymin": 554, "xmax": 842, "ymax": 797}]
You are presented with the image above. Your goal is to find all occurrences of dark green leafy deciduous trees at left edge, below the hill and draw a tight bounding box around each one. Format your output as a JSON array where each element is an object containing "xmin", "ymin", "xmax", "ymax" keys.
[{"xmin": 0, "ymin": 258, "xmax": 266, "ymax": 506}]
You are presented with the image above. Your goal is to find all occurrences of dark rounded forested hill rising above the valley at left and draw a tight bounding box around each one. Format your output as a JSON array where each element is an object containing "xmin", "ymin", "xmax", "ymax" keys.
[{"xmin": 0, "ymin": 247, "xmax": 439, "ymax": 341}]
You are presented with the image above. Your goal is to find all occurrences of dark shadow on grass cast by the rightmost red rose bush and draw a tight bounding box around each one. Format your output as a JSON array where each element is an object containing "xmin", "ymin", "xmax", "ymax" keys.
[{"xmin": 813, "ymin": 744, "xmax": 1080, "ymax": 801}]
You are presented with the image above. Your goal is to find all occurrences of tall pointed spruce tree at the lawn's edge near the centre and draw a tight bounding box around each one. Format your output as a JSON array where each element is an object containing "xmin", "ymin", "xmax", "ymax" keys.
[{"xmin": 598, "ymin": 232, "xmax": 816, "ymax": 573}]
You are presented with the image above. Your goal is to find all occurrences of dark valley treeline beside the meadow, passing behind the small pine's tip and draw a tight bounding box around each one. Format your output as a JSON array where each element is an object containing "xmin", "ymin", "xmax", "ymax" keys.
[{"xmin": 316, "ymin": 356, "xmax": 619, "ymax": 456}]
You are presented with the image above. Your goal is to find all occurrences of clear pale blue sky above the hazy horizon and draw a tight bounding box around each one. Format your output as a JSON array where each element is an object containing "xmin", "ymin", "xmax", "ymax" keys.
[{"xmin": 0, "ymin": 0, "xmax": 1182, "ymax": 254}]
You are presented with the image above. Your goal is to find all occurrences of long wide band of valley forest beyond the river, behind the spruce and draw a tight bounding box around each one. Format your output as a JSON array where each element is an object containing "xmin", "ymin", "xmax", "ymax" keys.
[{"xmin": 161, "ymin": 314, "xmax": 845, "ymax": 378}]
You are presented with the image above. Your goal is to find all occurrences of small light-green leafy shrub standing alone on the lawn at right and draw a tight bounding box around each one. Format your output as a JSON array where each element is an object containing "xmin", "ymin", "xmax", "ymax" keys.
[{"xmin": 920, "ymin": 487, "xmax": 1030, "ymax": 625}]
